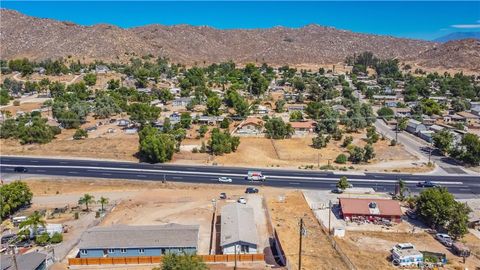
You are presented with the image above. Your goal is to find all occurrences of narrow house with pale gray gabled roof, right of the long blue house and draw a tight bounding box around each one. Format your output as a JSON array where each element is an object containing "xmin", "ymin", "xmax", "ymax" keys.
[{"xmin": 220, "ymin": 203, "xmax": 258, "ymax": 254}]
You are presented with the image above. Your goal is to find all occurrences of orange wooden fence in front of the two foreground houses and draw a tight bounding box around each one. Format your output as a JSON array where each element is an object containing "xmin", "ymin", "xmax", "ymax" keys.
[{"xmin": 68, "ymin": 254, "xmax": 265, "ymax": 265}]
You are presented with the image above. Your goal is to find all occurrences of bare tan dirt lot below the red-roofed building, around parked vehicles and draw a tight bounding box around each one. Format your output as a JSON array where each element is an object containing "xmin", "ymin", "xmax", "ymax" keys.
[{"xmin": 337, "ymin": 231, "xmax": 480, "ymax": 269}]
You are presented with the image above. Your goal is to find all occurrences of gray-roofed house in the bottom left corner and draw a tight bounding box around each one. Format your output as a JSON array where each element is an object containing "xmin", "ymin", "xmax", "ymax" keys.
[{"xmin": 0, "ymin": 252, "xmax": 47, "ymax": 270}]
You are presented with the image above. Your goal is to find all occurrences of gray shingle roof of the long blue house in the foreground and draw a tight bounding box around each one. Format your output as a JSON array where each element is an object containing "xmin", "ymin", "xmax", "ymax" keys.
[{"xmin": 79, "ymin": 223, "xmax": 199, "ymax": 249}]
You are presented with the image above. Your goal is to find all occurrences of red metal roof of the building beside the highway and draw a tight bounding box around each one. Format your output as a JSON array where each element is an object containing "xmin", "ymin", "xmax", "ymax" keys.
[{"xmin": 339, "ymin": 198, "xmax": 402, "ymax": 216}]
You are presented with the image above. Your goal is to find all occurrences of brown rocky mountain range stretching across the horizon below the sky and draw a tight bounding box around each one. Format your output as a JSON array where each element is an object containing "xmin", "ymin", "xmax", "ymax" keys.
[{"xmin": 0, "ymin": 9, "xmax": 480, "ymax": 70}]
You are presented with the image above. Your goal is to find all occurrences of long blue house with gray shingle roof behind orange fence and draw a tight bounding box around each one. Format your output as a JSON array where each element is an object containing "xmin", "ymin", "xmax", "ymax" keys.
[{"xmin": 78, "ymin": 223, "xmax": 199, "ymax": 258}]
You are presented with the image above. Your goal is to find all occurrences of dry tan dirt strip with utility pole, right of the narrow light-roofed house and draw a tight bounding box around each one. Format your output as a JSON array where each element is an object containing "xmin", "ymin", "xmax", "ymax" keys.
[{"xmin": 268, "ymin": 191, "xmax": 347, "ymax": 270}]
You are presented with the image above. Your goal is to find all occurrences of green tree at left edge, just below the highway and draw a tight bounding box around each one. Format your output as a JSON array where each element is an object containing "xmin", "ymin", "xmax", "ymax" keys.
[{"xmin": 0, "ymin": 181, "xmax": 33, "ymax": 219}]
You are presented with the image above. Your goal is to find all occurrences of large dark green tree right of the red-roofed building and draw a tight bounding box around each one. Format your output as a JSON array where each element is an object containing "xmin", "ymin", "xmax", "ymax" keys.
[{"xmin": 416, "ymin": 187, "xmax": 472, "ymax": 239}]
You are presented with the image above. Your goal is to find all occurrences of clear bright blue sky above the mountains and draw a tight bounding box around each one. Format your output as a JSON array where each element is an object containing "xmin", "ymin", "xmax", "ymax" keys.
[{"xmin": 0, "ymin": 0, "xmax": 480, "ymax": 40}]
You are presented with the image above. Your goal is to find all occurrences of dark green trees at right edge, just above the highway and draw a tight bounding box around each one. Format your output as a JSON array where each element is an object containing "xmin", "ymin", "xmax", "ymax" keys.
[{"xmin": 433, "ymin": 130, "xmax": 480, "ymax": 166}]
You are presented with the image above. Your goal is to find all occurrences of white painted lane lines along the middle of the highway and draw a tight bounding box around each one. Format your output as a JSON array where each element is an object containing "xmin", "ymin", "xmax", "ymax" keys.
[{"xmin": 0, "ymin": 164, "xmax": 463, "ymax": 185}]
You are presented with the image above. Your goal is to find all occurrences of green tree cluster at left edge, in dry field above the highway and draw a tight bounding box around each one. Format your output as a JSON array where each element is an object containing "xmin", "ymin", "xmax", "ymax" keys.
[{"xmin": 0, "ymin": 113, "xmax": 61, "ymax": 144}]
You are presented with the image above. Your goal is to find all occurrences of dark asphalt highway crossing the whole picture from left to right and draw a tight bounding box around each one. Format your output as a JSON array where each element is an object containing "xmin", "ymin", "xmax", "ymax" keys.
[{"xmin": 0, "ymin": 156, "xmax": 480, "ymax": 197}]
